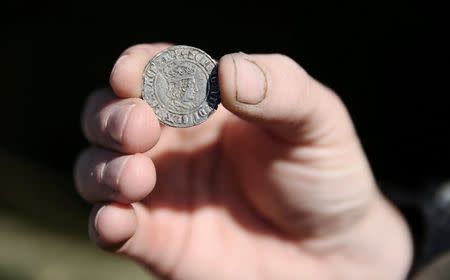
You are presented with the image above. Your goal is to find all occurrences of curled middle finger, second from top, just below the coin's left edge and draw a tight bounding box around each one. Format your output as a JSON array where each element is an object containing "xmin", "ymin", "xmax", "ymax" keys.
[{"xmin": 82, "ymin": 90, "xmax": 160, "ymax": 153}]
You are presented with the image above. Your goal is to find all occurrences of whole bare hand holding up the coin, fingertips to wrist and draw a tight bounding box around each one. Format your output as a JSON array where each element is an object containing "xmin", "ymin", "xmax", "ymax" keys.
[{"xmin": 75, "ymin": 44, "xmax": 412, "ymax": 280}]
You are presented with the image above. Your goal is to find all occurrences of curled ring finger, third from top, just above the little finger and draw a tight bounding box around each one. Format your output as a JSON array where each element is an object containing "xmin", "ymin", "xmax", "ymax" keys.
[{"xmin": 75, "ymin": 148, "xmax": 156, "ymax": 203}]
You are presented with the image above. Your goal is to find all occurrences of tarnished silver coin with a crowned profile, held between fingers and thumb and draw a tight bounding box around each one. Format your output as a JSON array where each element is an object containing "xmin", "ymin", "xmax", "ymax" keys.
[{"xmin": 142, "ymin": 46, "xmax": 220, "ymax": 127}]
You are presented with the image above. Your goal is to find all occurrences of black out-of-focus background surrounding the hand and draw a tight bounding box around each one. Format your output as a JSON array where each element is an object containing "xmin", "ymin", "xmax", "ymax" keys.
[{"xmin": 0, "ymin": 0, "xmax": 450, "ymax": 279}]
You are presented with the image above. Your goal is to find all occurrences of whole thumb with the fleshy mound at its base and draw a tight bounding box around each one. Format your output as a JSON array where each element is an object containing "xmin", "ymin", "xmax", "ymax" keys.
[{"xmin": 219, "ymin": 53, "xmax": 375, "ymax": 233}]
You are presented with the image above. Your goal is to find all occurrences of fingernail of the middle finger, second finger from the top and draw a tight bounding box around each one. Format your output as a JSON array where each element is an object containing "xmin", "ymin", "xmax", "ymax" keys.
[{"xmin": 106, "ymin": 103, "xmax": 136, "ymax": 145}]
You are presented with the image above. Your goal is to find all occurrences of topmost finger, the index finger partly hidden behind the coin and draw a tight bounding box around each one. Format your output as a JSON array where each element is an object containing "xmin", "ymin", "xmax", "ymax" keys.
[{"xmin": 109, "ymin": 43, "xmax": 171, "ymax": 98}]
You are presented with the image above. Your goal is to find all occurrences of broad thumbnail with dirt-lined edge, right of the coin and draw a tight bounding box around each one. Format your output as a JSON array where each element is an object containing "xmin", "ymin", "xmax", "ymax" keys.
[{"xmin": 232, "ymin": 53, "xmax": 267, "ymax": 105}]
